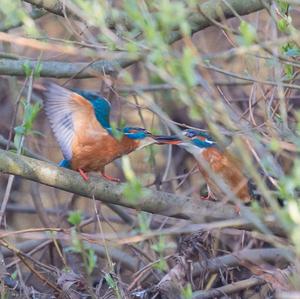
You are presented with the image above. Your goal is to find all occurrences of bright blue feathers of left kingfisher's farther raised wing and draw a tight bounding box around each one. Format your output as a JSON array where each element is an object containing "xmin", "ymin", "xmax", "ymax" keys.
[{"xmin": 72, "ymin": 88, "xmax": 111, "ymax": 128}]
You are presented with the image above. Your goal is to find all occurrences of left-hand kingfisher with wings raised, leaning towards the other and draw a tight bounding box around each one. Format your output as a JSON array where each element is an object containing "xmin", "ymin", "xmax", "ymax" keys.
[{"xmin": 44, "ymin": 82, "xmax": 162, "ymax": 182}]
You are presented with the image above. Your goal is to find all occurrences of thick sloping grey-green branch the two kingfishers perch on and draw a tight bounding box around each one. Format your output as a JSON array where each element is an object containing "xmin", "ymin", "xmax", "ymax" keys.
[{"xmin": 0, "ymin": 150, "xmax": 237, "ymax": 223}]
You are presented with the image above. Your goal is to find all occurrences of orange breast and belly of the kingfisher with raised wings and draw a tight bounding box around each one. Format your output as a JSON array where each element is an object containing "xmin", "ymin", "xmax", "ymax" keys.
[{"xmin": 71, "ymin": 111, "xmax": 139, "ymax": 172}]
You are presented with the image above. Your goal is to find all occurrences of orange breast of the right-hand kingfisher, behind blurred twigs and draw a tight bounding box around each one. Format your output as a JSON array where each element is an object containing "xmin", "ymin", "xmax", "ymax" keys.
[{"xmin": 199, "ymin": 147, "xmax": 251, "ymax": 202}]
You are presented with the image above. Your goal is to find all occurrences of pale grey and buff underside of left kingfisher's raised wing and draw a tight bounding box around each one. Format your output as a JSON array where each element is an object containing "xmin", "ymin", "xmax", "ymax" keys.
[{"xmin": 44, "ymin": 82, "xmax": 94, "ymax": 161}]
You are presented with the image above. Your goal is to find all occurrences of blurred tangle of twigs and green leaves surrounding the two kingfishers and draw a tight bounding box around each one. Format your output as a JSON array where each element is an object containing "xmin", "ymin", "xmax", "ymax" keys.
[{"xmin": 0, "ymin": 0, "xmax": 300, "ymax": 298}]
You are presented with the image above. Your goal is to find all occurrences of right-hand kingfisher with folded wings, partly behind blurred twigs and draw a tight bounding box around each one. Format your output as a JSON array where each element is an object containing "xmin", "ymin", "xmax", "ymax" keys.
[{"xmin": 157, "ymin": 129, "xmax": 252, "ymax": 203}]
